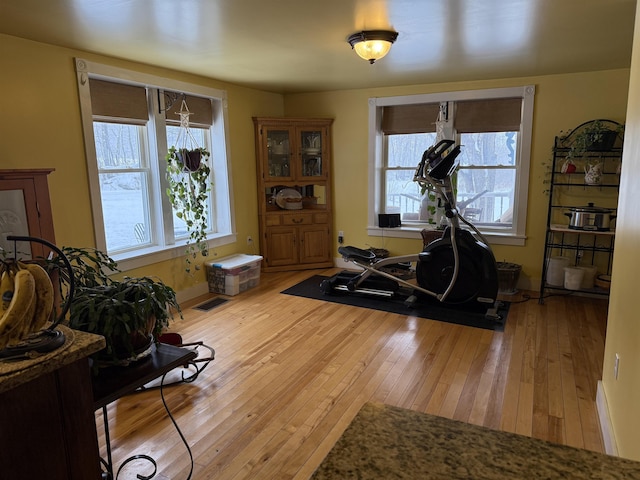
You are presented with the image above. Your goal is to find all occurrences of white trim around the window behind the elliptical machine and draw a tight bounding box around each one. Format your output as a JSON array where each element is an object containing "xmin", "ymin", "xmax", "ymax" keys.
[{"xmin": 367, "ymin": 85, "xmax": 535, "ymax": 245}]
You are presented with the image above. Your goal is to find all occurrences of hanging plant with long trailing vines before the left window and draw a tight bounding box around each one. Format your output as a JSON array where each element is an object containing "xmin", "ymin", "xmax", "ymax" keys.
[{"xmin": 166, "ymin": 146, "xmax": 211, "ymax": 273}]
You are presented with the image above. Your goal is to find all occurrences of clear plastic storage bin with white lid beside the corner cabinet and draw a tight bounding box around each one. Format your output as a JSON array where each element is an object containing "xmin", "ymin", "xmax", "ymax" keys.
[{"xmin": 205, "ymin": 253, "xmax": 262, "ymax": 295}]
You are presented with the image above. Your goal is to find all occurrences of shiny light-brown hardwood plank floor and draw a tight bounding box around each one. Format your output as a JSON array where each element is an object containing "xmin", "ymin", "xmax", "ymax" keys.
[{"xmin": 96, "ymin": 270, "xmax": 607, "ymax": 480}]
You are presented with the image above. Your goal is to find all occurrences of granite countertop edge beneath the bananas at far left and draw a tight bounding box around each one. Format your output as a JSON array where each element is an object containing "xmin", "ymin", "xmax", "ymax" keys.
[{"xmin": 0, "ymin": 325, "xmax": 105, "ymax": 393}]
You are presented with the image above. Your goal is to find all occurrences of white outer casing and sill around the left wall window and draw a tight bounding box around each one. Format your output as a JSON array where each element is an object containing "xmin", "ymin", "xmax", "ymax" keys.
[{"xmin": 75, "ymin": 58, "xmax": 237, "ymax": 271}]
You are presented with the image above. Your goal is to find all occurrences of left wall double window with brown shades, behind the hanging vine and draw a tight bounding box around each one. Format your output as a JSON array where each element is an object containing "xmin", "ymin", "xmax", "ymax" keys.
[{"xmin": 76, "ymin": 59, "xmax": 235, "ymax": 270}]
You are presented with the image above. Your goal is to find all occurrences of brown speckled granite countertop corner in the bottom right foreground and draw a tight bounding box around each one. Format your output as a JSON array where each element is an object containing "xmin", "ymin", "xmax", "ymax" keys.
[{"xmin": 311, "ymin": 403, "xmax": 640, "ymax": 480}]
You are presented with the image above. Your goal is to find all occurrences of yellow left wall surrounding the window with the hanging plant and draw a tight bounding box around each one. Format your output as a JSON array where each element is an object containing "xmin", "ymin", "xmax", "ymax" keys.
[{"xmin": 0, "ymin": 35, "xmax": 283, "ymax": 290}]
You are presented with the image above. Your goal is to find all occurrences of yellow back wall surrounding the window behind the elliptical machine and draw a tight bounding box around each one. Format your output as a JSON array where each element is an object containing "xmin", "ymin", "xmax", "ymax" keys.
[{"xmin": 285, "ymin": 71, "xmax": 629, "ymax": 289}]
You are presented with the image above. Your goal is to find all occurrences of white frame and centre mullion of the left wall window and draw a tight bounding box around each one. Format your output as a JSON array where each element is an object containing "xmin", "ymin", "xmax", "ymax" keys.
[{"xmin": 75, "ymin": 58, "xmax": 237, "ymax": 270}]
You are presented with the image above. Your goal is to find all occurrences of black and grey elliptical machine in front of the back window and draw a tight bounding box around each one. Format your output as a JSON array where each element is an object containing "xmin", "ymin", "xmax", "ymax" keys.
[{"xmin": 320, "ymin": 140, "xmax": 499, "ymax": 318}]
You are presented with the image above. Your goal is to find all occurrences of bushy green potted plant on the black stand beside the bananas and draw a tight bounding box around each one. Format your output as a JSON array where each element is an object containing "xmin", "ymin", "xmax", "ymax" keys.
[{"xmin": 47, "ymin": 247, "xmax": 182, "ymax": 366}]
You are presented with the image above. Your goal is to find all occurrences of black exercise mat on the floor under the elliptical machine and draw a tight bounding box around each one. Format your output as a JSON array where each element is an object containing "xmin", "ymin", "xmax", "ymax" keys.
[{"xmin": 280, "ymin": 275, "xmax": 510, "ymax": 331}]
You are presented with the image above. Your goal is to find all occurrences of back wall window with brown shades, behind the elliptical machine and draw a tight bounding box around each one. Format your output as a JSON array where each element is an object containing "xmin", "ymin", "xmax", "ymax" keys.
[{"xmin": 369, "ymin": 86, "xmax": 534, "ymax": 245}]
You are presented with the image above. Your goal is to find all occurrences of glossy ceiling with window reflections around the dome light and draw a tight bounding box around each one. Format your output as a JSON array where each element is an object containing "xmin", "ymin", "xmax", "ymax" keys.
[{"xmin": 0, "ymin": 0, "xmax": 636, "ymax": 93}]
